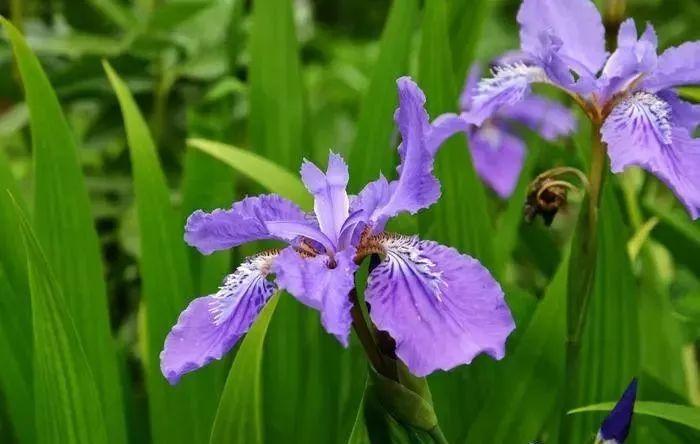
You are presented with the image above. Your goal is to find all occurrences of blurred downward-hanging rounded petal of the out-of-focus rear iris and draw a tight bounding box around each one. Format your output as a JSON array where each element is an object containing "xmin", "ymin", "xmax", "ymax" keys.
[{"xmin": 469, "ymin": 125, "xmax": 525, "ymax": 199}]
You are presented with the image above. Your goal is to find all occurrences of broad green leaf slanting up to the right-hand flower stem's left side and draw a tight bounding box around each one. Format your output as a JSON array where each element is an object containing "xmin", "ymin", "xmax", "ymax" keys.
[{"xmin": 464, "ymin": 251, "xmax": 568, "ymax": 443}]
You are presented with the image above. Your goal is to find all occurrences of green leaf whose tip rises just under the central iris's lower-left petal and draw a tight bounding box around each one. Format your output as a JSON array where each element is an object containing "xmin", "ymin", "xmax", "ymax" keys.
[{"xmin": 209, "ymin": 294, "xmax": 283, "ymax": 444}]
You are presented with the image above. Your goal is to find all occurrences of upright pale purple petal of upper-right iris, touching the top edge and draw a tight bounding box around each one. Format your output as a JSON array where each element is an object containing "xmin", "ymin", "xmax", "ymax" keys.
[{"xmin": 518, "ymin": 0, "xmax": 607, "ymax": 74}]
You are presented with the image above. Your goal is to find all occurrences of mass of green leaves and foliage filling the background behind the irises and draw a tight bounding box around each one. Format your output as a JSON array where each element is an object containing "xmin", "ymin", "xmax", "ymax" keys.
[{"xmin": 0, "ymin": 0, "xmax": 700, "ymax": 444}]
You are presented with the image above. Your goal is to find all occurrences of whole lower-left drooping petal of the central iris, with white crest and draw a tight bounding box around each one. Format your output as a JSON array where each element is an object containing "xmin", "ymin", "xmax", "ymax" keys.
[{"xmin": 160, "ymin": 254, "xmax": 275, "ymax": 384}]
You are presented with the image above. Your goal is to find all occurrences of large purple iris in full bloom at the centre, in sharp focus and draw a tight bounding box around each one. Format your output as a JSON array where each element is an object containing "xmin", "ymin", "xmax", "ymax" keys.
[{"xmin": 161, "ymin": 77, "xmax": 515, "ymax": 384}]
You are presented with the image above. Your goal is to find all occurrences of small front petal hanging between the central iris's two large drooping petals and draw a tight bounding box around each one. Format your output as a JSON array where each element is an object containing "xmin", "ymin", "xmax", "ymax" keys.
[{"xmin": 273, "ymin": 247, "xmax": 357, "ymax": 347}]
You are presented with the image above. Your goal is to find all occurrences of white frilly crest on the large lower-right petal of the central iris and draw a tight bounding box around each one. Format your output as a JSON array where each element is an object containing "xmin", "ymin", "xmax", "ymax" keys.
[{"xmin": 381, "ymin": 235, "xmax": 447, "ymax": 301}]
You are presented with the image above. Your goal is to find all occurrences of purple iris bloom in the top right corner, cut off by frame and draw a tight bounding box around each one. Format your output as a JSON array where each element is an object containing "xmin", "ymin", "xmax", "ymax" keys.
[{"xmin": 469, "ymin": 0, "xmax": 700, "ymax": 219}]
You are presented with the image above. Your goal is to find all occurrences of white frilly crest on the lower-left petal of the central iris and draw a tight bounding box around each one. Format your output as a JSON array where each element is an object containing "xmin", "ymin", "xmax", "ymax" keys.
[{"xmin": 209, "ymin": 252, "xmax": 277, "ymax": 325}]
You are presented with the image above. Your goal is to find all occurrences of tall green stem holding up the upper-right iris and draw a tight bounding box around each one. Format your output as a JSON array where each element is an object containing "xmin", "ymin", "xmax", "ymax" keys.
[{"xmin": 561, "ymin": 123, "xmax": 606, "ymax": 442}]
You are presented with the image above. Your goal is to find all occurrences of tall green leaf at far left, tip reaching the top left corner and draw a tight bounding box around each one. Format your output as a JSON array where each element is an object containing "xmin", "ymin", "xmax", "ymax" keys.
[{"xmin": 3, "ymin": 21, "xmax": 126, "ymax": 443}]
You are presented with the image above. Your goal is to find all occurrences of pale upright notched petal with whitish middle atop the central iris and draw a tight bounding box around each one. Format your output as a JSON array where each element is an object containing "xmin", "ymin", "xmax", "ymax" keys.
[{"xmin": 301, "ymin": 152, "xmax": 350, "ymax": 243}]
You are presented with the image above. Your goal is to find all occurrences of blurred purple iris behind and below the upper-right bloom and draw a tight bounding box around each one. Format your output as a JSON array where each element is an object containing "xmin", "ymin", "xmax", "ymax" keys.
[{"xmin": 460, "ymin": 61, "xmax": 576, "ymax": 199}]
